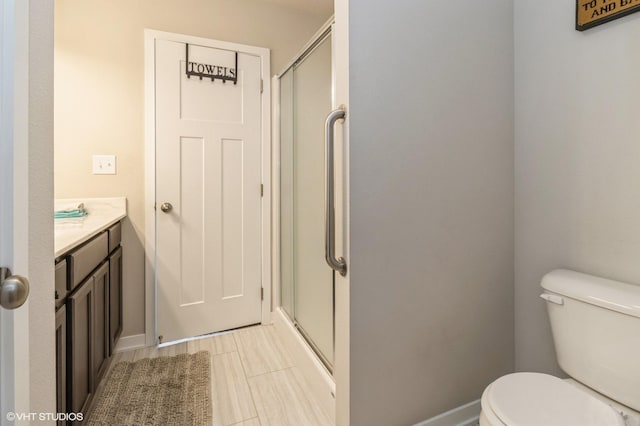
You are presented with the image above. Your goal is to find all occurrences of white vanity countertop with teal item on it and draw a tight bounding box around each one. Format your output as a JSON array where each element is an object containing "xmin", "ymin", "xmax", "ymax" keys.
[{"xmin": 54, "ymin": 197, "xmax": 127, "ymax": 258}]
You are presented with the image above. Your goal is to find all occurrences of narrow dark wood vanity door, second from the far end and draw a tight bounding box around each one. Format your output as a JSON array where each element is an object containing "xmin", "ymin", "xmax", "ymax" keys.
[{"xmin": 92, "ymin": 262, "xmax": 109, "ymax": 386}]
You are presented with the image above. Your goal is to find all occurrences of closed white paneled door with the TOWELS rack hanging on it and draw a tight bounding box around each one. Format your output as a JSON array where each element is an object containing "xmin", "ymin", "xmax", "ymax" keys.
[{"xmin": 155, "ymin": 39, "xmax": 262, "ymax": 342}]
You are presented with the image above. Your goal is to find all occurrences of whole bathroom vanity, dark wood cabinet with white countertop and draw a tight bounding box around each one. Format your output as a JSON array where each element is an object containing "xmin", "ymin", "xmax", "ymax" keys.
[{"xmin": 55, "ymin": 198, "xmax": 126, "ymax": 415}]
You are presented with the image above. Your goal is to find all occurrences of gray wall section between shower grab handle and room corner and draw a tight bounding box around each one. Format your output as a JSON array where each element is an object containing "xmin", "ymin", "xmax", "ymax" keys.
[{"xmin": 349, "ymin": 0, "xmax": 514, "ymax": 426}]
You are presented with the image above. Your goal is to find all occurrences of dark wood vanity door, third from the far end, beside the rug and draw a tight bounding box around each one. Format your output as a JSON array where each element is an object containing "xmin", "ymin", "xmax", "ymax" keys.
[{"xmin": 67, "ymin": 277, "xmax": 94, "ymax": 413}]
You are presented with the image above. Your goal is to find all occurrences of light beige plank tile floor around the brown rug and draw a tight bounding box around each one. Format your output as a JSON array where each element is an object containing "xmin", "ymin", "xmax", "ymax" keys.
[{"xmin": 95, "ymin": 325, "xmax": 333, "ymax": 426}]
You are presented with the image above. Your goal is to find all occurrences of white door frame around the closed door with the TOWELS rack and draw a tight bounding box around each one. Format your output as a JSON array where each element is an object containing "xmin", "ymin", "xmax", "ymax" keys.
[{"xmin": 144, "ymin": 29, "xmax": 272, "ymax": 346}]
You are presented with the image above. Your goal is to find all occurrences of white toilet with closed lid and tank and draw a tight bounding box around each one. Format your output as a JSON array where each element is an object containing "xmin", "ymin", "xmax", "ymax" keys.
[{"xmin": 480, "ymin": 270, "xmax": 640, "ymax": 426}]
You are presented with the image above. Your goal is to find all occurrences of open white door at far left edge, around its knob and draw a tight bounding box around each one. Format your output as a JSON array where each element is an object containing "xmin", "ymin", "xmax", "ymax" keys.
[{"xmin": 0, "ymin": 0, "xmax": 30, "ymax": 418}]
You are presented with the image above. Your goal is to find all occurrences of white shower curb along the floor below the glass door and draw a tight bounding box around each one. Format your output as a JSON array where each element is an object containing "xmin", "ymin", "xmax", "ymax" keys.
[{"xmin": 272, "ymin": 308, "xmax": 336, "ymax": 419}]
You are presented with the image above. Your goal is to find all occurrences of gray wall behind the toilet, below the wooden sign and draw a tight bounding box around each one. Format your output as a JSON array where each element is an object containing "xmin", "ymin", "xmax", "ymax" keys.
[{"xmin": 515, "ymin": 0, "xmax": 640, "ymax": 373}]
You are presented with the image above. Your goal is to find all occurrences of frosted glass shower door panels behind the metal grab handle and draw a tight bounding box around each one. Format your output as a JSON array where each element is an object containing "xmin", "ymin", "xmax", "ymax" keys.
[{"xmin": 280, "ymin": 34, "xmax": 334, "ymax": 370}]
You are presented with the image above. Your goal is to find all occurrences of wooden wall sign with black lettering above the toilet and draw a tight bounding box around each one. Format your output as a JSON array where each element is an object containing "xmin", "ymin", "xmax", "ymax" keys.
[{"xmin": 576, "ymin": 0, "xmax": 640, "ymax": 31}]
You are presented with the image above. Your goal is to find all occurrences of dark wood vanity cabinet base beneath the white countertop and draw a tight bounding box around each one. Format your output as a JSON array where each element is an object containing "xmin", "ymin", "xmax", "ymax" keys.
[{"xmin": 56, "ymin": 223, "xmax": 122, "ymax": 420}]
